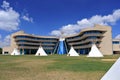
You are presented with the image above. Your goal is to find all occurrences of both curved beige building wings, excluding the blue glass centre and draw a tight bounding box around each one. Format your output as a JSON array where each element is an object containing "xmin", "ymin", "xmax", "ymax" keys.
[{"xmin": 3, "ymin": 25, "xmax": 119, "ymax": 55}]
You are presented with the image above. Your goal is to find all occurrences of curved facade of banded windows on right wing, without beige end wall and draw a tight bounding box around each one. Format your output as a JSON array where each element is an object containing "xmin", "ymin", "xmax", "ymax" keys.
[{"xmin": 66, "ymin": 30, "xmax": 104, "ymax": 54}]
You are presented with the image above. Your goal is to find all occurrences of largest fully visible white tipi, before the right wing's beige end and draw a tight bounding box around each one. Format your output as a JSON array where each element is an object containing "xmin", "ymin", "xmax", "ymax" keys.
[{"xmin": 87, "ymin": 44, "xmax": 103, "ymax": 57}]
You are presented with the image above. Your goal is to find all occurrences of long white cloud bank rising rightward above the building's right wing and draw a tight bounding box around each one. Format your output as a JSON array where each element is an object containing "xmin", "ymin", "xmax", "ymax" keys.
[{"xmin": 50, "ymin": 9, "xmax": 120, "ymax": 36}]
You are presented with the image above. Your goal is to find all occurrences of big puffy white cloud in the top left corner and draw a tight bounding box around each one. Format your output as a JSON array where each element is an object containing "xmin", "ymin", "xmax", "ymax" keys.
[{"xmin": 0, "ymin": 1, "xmax": 20, "ymax": 31}]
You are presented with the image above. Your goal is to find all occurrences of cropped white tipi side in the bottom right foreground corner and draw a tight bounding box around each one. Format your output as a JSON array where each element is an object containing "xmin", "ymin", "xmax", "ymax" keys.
[{"xmin": 101, "ymin": 58, "xmax": 120, "ymax": 80}]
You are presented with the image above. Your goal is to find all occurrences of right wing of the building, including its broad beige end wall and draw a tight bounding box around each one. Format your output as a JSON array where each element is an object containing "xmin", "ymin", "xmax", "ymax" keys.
[{"xmin": 66, "ymin": 25, "xmax": 113, "ymax": 55}]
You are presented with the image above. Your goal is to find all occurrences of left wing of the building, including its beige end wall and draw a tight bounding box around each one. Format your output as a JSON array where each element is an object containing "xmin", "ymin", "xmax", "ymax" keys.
[{"xmin": 3, "ymin": 31, "xmax": 59, "ymax": 54}]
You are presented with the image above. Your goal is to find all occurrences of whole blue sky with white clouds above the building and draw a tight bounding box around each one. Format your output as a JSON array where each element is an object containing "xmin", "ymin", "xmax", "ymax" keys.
[{"xmin": 0, "ymin": 0, "xmax": 120, "ymax": 47}]
